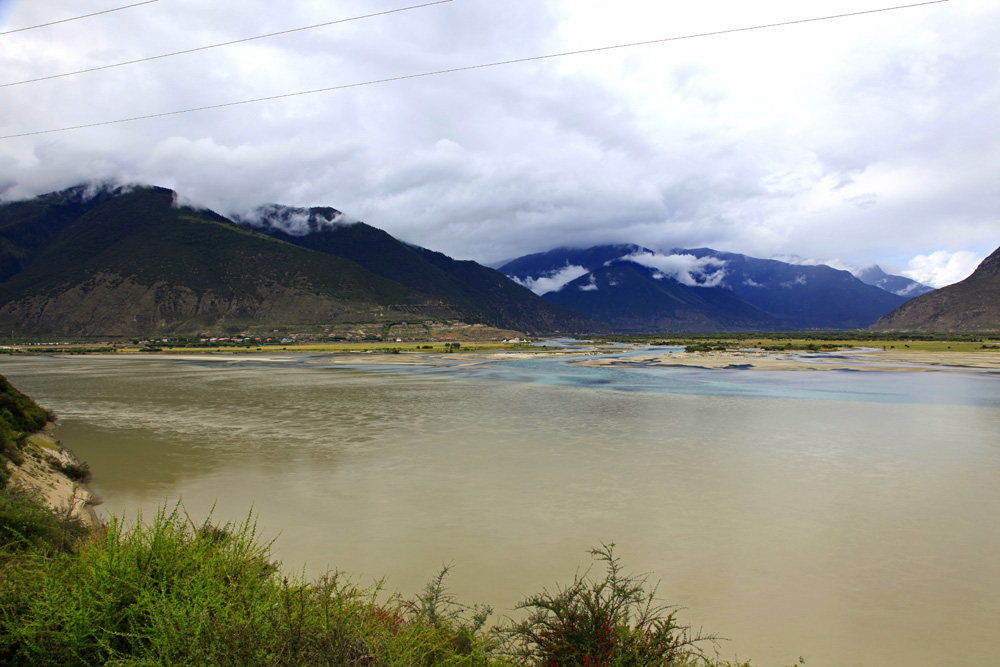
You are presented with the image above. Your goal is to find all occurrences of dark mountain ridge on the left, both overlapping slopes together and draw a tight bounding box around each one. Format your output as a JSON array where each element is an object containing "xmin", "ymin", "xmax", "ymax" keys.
[{"xmin": 0, "ymin": 186, "xmax": 604, "ymax": 335}]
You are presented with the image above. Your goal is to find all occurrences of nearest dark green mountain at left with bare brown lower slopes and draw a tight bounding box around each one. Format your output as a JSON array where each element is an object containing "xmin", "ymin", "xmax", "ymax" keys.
[{"xmin": 0, "ymin": 187, "xmax": 459, "ymax": 335}]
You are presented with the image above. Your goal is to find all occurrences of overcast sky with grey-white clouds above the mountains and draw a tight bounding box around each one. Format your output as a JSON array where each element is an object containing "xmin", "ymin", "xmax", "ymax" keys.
[{"xmin": 0, "ymin": 0, "xmax": 1000, "ymax": 287}]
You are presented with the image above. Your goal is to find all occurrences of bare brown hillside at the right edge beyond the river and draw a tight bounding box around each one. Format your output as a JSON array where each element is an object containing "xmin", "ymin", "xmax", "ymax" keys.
[{"xmin": 870, "ymin": 248, "xmax": 1000, "ymax": 333}]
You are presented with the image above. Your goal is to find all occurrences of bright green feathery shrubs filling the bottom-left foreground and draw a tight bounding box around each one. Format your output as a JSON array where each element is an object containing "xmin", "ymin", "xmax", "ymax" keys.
[{"xmin": 0, "ymin": 508, "xmax": 508, "ymax": 667}]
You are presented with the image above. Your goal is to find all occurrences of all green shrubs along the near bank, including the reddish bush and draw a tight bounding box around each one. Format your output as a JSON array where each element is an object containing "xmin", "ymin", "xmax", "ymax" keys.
[{"xmin": 0, "ymin": 500, "xmax": 780, "ymax": 667}]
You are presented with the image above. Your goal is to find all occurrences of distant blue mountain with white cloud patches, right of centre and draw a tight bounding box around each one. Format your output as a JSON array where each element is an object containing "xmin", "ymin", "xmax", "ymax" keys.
[{"xmin": 501, "ymin": 245, "xmax": 906, "ymax": 330}]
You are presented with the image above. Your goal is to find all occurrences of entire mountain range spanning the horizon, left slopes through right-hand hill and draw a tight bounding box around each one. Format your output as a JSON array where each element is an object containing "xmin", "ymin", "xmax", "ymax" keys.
[{"xmin": 0, "ymin": 185, "xmax": 988, "ymax": 336}]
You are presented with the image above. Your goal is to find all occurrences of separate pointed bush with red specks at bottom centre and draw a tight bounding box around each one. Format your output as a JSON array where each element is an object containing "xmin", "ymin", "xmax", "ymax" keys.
[{"xmin": 504, "ymin": 544, "xmax": 716, "ymax": 667}]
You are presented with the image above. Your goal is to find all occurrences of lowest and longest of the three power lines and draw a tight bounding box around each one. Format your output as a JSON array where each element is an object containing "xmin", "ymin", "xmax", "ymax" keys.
[{"xmin": 0, "ymin": 0, "xmax": 949, "ymax": 139}]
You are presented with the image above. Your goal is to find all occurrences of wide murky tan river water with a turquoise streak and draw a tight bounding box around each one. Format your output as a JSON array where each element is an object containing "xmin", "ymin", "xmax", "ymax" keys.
[{"xmin": 0, "ymin": 358, "xmax": 1000, "ymax": 667}]
